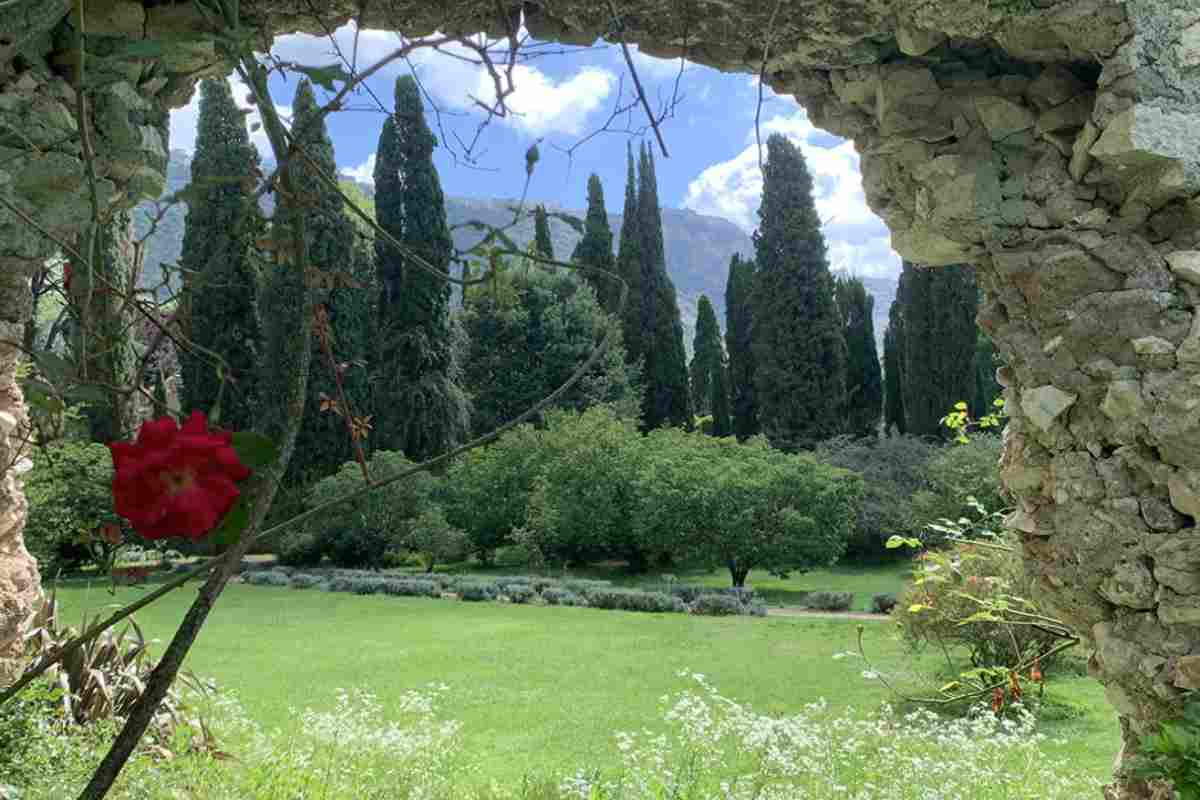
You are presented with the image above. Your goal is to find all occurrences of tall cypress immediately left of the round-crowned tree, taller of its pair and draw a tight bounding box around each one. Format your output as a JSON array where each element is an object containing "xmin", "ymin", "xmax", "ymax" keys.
[{"xmin": 373, "ymin": 76, "xmax": 469, "ymax": 461}]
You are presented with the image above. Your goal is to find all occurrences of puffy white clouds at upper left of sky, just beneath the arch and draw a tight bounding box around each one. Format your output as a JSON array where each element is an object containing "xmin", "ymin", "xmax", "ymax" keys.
[{"xmin": 271, "ymin": 23, "xmax": 617, "ymax": 136}]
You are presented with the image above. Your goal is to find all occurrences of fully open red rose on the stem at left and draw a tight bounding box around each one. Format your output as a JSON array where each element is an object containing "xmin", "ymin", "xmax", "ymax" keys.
[{"xmin": 108, "ymin": 411, "xmax": 250, "ymax": 539}]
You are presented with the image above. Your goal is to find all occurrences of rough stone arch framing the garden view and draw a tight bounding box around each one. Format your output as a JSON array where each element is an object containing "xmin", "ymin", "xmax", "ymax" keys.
[{"xmin": 0, "ymin": 0, "xmax": 1200, "ymax": 796}]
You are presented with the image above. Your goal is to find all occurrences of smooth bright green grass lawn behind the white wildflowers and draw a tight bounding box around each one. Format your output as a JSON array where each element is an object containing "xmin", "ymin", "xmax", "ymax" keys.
[{"xmin": 51, "ymin": 575, "xmax": 1117, "ymax": 784}]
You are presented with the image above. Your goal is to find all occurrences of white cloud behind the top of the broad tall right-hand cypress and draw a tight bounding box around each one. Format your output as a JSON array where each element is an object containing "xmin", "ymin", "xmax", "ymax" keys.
[{"xmin": 683, "ymin": 112, "xmax": 900, "ymax": 276}]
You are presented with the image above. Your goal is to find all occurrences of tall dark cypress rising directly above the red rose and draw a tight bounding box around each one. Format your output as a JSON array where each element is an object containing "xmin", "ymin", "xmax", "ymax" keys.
[{"xmin": 179, "ymin": 80, "xmax": 263, "ymax": 429}]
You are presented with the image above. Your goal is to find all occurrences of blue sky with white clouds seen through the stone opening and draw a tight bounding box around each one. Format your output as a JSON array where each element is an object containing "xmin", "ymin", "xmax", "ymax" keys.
[{"xmin": 170, "ymin": 25, "xmax": 900, "ymax": 277}]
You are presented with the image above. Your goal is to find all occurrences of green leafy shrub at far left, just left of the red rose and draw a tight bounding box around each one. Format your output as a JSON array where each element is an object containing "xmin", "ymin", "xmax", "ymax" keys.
[{"xmin": 24, "ymin": 441, "xmax": 129, "ymax": 576}]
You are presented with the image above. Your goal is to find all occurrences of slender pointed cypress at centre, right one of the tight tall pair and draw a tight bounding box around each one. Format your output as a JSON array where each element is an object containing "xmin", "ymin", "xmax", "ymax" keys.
[{"xmin": 637, "ymin": 145, "xmax": 692, "ymax": 431}]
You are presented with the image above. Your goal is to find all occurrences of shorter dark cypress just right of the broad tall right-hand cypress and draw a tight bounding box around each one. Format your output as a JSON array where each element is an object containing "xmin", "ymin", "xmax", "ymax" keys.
[{"xmin": 835, "ymin": 278, "xmax": 883, "ymax": 437}]
